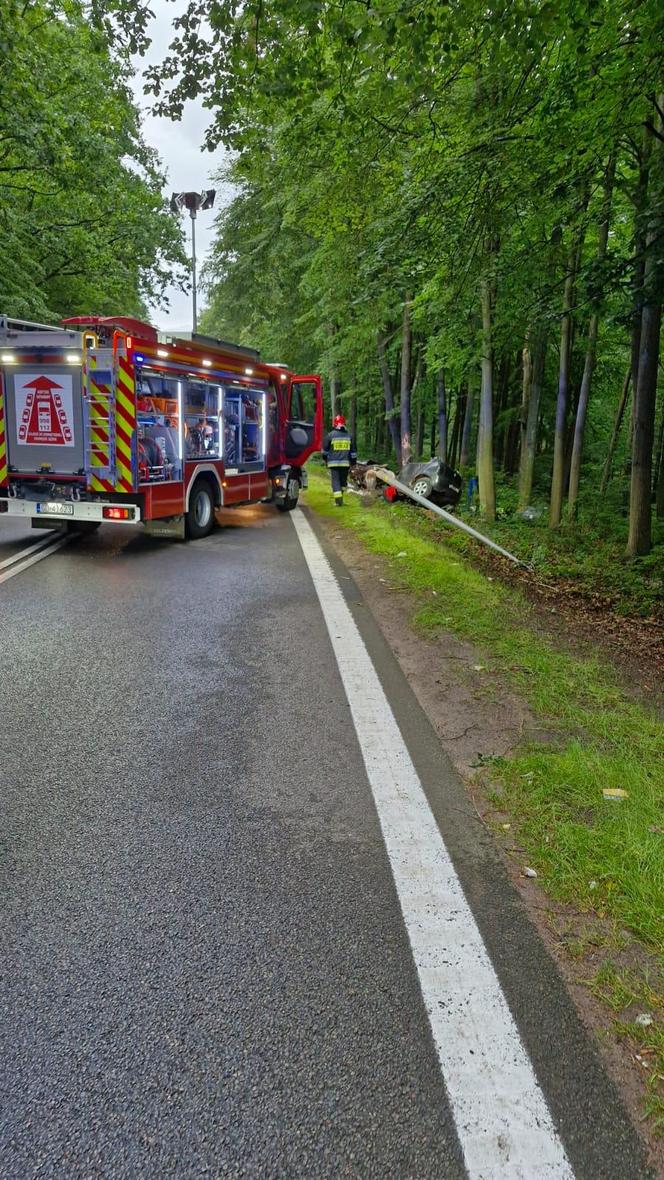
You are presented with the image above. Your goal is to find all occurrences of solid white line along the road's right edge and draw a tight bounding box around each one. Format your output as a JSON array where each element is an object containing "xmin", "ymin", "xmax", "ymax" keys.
[{"xmin": 291, "ymin": 511, "xmax": 573, "ymax": 1180}]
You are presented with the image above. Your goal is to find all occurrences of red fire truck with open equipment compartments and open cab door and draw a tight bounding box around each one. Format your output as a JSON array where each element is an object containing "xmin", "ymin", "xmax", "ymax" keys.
[{"xmin": 0, "ymin": 316, "xmax": 323, "ymax": 539}]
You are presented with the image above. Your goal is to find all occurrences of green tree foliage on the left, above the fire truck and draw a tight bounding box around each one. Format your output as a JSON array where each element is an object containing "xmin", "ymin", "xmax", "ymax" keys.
[{"xmin": 0, "ymin": 0, "xmax": 186, "ymax": 320}]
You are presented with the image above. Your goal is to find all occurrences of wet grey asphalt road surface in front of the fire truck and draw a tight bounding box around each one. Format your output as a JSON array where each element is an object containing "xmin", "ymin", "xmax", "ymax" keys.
[{"xmin": 0, "ymin": 509, "xmax": 647, "ymax": 1180}]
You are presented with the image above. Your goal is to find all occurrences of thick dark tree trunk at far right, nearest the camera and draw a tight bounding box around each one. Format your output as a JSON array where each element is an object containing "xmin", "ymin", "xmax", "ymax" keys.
[{"xmin": 627, "ymin": 94, "xmax": 664, "ymax": 557}]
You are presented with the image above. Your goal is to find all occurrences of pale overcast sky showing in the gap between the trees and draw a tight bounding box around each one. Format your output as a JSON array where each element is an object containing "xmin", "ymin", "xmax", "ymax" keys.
[{"xmin": 133, "ymin": 0, "xmax": 230, "ymax": 332}]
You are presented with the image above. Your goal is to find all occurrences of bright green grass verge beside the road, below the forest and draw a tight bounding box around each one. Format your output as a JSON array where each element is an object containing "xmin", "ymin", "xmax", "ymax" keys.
[{"xmin": 307, "ymin": 470, "xmax": 664, "ymax": 1133}]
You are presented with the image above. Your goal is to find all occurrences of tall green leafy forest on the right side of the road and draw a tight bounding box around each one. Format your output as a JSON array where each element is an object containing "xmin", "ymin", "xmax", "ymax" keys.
[{"xmin": 141, "ymin": 0, "xmax": 664, "ymax": 557}]
